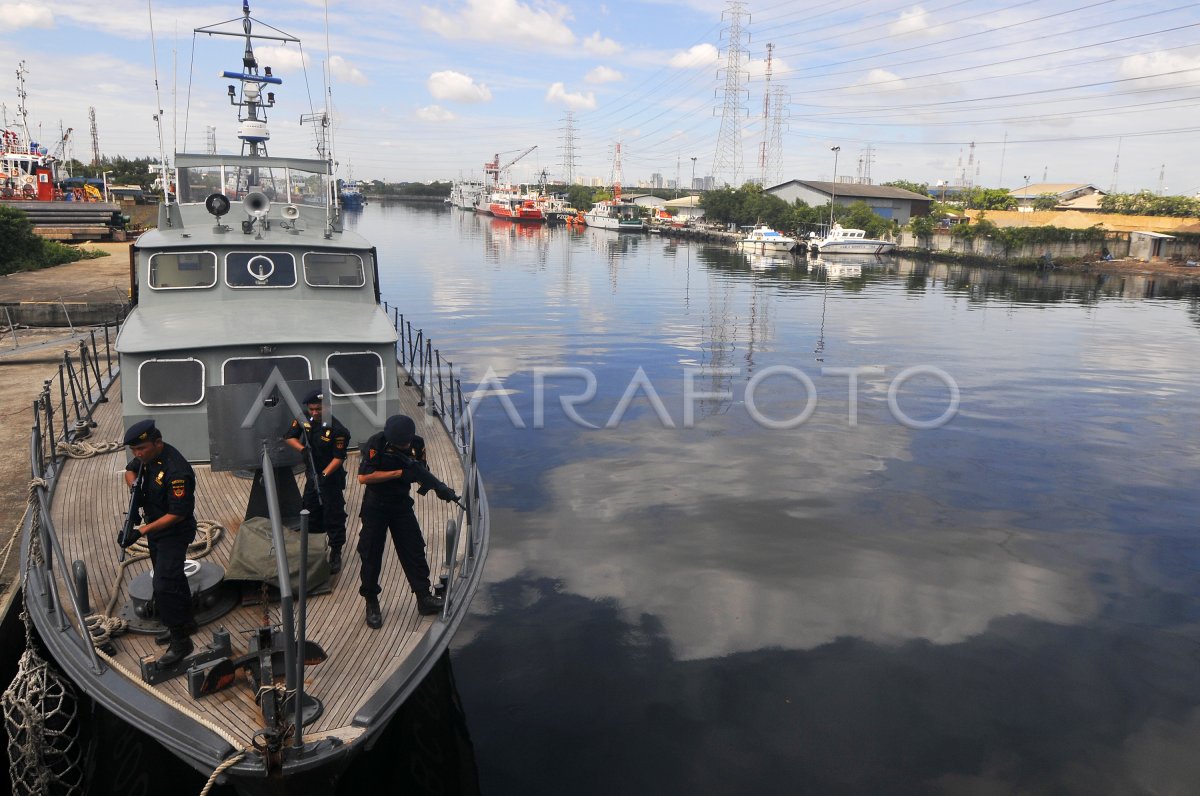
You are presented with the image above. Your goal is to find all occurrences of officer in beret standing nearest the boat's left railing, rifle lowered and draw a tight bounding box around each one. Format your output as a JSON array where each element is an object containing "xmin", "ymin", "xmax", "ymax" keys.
[{"xmin": 124, "ymin": 419, "xmax": 197, "ymax": 669}]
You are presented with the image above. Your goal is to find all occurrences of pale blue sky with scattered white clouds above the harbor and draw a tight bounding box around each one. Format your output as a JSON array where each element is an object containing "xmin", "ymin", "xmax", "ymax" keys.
[{"xmin": 0, "ymin": 0, "xmax": 1200, "ymax": 196}]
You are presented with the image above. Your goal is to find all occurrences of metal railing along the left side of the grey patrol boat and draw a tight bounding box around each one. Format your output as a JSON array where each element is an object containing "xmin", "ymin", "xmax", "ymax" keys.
[{"xmin": 25, "ymin": 319, "xmax": 120, "ymax": 674}]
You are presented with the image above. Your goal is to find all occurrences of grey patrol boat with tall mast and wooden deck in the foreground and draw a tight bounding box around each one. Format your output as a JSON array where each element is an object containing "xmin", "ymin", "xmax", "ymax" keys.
[{"xmin": 10, "ymin": 0, "xmax": 488, "ymax": 794}]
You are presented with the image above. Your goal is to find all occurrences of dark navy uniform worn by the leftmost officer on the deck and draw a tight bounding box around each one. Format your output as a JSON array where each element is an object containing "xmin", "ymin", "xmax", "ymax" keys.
[{"xmin": 125, "ymin": 443, "xmax": 196, "ymax": 628}]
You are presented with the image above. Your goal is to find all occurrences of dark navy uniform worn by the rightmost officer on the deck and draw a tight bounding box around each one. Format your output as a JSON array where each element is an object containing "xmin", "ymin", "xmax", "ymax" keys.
[{"xmin": 358, "ymin": 431, "xmax": 430, "ymax": 600}]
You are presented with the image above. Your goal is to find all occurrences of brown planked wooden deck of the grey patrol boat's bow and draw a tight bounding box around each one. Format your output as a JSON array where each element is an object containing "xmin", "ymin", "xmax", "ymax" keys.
[{"xmin": 45, "ymin": 374, "xmax": 462, "ymax": 748}]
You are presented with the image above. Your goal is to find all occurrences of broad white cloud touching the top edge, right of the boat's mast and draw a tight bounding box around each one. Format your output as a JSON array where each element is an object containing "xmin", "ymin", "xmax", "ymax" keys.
[{"xmin": 421, "ymin": 0, "xmax": 576, "ymax": 47}]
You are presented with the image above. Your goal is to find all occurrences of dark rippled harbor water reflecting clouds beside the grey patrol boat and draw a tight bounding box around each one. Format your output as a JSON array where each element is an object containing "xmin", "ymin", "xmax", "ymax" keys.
[{"xmin": 88, "ymin": 204, "xmax": 1200, "ymax": 795}]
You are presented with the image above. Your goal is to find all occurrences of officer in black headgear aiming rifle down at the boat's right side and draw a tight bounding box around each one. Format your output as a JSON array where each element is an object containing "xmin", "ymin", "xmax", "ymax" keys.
[{"xmin": 359, "ymin": 414, "xmax": 458, "ymax": 629}]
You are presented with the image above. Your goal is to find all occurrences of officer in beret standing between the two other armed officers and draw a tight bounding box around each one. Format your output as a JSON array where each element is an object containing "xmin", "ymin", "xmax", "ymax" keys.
[{"xmin": 283, "ymin": 390, "xmax": 350, "ymax": 575}]
